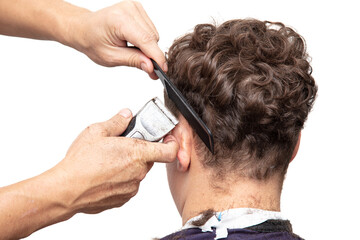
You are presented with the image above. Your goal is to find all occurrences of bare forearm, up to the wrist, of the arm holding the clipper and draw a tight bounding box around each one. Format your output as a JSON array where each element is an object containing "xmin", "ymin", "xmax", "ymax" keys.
[{"xmin": 0, "ymin": 166, "xmax": 75, "ymax": 239}]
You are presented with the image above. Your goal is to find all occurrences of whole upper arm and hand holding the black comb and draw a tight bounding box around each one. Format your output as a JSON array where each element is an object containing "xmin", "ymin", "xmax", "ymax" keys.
[{"xmin": 0, "ymin": 0, "xmax": 167, "ymax": 79}]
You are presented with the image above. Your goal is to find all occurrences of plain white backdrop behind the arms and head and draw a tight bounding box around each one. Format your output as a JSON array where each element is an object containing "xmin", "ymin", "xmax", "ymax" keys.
[{"xmin": 0, "ymin": 0, "xmax": 360, "ymax": 239}]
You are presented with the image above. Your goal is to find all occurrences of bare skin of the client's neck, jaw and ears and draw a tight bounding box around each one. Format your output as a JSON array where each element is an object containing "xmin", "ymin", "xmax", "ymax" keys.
[{"xmin": 166, "ymin": 116, "xmax": 300, "ymax": 224}]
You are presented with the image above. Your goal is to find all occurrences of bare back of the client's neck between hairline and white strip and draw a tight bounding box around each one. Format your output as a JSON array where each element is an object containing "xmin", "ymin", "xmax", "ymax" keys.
[{"xmin": 181, "ymin": 166, "xmax": 282, "ymax": 224}]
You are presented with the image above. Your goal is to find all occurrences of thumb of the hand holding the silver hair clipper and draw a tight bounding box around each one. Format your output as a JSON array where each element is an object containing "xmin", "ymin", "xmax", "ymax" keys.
[{"xmin": 100, "ymin": 108, "xmax": 132, "ymax": 137}]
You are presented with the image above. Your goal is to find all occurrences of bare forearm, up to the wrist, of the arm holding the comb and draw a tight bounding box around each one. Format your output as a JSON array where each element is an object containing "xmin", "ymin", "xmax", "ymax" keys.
[{"xmin": 0, "ymin": 0, "xmax": 89, "ymax": 45}]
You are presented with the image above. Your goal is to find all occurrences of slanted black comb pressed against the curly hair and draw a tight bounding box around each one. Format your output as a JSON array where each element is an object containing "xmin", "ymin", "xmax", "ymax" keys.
[{"xmin": 151, "ymin": 59, "xmax": 214, "ymax": 154}]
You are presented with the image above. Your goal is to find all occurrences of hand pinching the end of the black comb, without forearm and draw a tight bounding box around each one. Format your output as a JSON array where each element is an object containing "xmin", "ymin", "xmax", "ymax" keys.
[{"xmin": 68, "ymin": 1, "xmax": 167, "ymax": 79}]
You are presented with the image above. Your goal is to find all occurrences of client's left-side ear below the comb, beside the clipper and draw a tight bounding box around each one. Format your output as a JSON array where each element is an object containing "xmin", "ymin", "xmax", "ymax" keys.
[{"xmin": 172, "ymin": 116, "xmax": 194, "ymax": 172}]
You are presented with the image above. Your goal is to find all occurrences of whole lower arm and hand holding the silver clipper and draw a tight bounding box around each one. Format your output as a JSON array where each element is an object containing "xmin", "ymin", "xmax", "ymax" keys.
[{"xmin": 0, "ymin": 109, "xmax": 178, "ymax": 239}]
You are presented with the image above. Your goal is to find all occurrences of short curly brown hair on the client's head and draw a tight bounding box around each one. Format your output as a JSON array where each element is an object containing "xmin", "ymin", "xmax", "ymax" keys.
[{"xmin": 165, "ymin": 19, "xmax": 317, "ymax": 180}]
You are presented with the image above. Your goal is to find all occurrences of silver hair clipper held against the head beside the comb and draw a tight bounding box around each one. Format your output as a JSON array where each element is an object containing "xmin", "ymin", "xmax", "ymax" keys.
[{"xmin": 121, "ymin": 97, "xmax": 179, "ymax": 142}]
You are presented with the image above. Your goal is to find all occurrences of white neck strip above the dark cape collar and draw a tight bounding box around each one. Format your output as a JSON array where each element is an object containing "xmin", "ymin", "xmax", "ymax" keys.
[{"xmin": 181, "ymin": 208, "xmax": 286, "ymax": 239}]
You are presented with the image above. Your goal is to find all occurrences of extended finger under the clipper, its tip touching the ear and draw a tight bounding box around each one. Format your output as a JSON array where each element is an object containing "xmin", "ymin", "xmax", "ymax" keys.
[{"xmin": 137, "ymin": 135, "xmax": 179, "ymax": 163}]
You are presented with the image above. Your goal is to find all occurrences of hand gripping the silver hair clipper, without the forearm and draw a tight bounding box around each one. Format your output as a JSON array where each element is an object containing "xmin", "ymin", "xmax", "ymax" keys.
[{"xmin": 53, "ymin": 110, "xmax": 179, "ymax": 213}]
